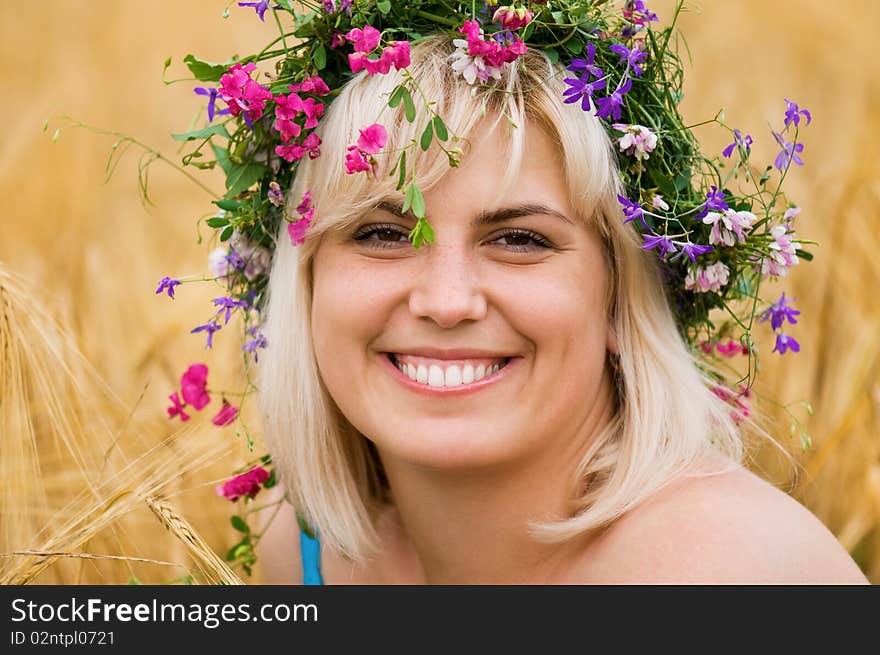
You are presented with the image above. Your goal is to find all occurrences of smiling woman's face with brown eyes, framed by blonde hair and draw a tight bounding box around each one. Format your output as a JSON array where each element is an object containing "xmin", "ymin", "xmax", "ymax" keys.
[{"xmin": 312, "ymin": 122, "xmax": 612, "ymax": 468}]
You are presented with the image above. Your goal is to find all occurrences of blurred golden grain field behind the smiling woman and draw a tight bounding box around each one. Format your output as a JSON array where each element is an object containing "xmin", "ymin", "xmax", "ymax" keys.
[{"xmin": 0, "ymin": 0, "xmax": 880, "ymax": 584}]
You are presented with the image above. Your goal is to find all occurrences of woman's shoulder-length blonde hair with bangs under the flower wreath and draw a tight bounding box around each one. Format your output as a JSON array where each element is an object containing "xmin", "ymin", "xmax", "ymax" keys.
[{"xmin": 259, "ymin": 36, "xmax": 760, "ymax": 558}]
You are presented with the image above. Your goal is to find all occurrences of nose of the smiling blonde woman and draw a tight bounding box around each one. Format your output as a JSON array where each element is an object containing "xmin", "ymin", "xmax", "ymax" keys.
[{"xmin": 409, "ymin": 241, "xmax": 486, "ymax": 328}]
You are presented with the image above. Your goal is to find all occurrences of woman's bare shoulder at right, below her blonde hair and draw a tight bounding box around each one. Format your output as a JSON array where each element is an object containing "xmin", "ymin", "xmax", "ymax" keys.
[{"xmin": 587, "ymin": 456, "xmax": 867, "ymax": 584}]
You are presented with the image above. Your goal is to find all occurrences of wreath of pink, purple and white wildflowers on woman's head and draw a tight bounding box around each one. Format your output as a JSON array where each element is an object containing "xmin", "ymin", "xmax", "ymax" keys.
[{"xmin": 89, "ymin": 0, "xmax": 813, "ymax": 574}]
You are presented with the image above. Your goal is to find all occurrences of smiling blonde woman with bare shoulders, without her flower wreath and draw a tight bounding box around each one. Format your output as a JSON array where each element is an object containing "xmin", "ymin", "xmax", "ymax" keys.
[{"xmin": 253, "ymin": 37, "xmax": 865, "ymax": 584}]
